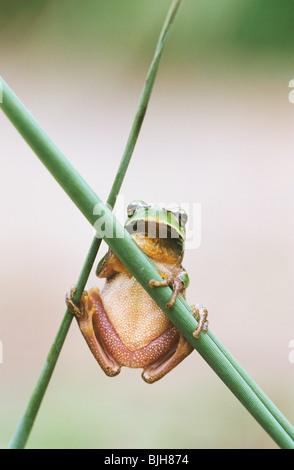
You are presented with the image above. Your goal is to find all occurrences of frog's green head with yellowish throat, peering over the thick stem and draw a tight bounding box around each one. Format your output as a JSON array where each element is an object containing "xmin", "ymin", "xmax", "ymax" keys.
[{"xmin": 125, "ymin": 200, "xmax": 188, "ymax": 258}]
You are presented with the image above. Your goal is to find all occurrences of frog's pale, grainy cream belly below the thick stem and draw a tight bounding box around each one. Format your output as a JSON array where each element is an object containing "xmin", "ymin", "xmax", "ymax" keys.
[{"xmin": 100, "ymin": 273, "xmax": 172, "ymax": 351}]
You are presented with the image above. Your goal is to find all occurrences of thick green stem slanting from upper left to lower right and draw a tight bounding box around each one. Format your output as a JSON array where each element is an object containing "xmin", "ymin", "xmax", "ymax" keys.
[{"xmin": 2, "ymin": 78, "xmax": 294, "ymax": 449}]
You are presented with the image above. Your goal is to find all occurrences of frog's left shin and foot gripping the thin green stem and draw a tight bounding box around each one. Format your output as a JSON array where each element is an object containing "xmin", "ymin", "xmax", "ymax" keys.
[{"xmin": 66, "ymin": 287, "xmax": 121, "ymax": 377}]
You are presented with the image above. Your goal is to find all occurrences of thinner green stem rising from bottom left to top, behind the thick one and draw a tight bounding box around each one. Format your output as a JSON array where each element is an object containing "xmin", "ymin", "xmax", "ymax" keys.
[{"xmin": 0, "ymin": 0, "xmax": 181, "ymax": 449}]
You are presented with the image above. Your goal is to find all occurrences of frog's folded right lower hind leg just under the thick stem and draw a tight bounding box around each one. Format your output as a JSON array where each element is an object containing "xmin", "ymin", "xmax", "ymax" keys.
[{"xmin": 142, "ymin": 334, "xmax": 193, "ymax": 384}]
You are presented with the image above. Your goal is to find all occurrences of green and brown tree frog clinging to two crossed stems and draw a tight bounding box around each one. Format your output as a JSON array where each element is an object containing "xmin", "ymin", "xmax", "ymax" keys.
[{"xmin": 66, "ymin": 201, "xmax": 208, "ymax": 383}]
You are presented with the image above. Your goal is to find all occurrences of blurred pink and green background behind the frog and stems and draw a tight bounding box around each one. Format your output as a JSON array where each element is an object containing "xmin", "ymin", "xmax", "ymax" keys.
[{"xmin": 0, "ymin": 0, "xmax": 294, "ymax": 449}]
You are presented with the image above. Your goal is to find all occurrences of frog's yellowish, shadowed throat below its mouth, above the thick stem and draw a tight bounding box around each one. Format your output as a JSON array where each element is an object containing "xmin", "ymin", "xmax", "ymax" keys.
[{"xmin": 132, "ymin": 233, "xmax": 183, "ymax": 264}]
